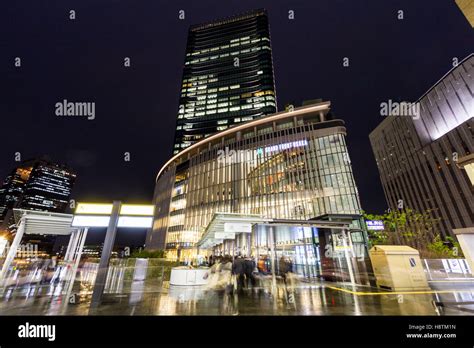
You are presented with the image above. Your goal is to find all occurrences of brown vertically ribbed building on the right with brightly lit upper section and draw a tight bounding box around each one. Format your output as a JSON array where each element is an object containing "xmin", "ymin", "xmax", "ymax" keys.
[{"xmin": 370, "ymin": 54, "xmax": 474, "ymax": 236}]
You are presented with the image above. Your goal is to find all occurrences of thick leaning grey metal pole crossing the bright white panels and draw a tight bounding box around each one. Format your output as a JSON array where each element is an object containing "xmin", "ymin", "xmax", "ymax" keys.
[{"xmin": 91, "ymin": 201, "xmax": 122, "ymax": 308}]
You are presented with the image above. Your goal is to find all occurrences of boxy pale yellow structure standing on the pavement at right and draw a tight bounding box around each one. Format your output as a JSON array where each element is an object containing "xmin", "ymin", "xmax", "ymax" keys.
[{"xmin": 369, "ymin": 245, "xmax": 430, "ymax": 291}]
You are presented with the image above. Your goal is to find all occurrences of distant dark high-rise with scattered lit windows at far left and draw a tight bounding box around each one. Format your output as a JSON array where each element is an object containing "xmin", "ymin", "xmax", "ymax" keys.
[{"xmin": 0, "ymin": 159, "xmax": 76, "ymax": 228}]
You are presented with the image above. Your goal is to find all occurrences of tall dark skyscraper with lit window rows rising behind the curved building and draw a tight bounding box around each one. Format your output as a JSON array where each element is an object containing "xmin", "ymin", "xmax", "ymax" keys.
[{"xmin": 173, "ymin": 9, "xmax": 277, "ymax": 154}]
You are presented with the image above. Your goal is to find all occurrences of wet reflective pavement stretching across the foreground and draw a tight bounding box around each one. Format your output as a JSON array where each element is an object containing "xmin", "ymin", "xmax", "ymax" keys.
[{"xmin": 0, "ymin": 280, "xmax": 474, "ymax": 315}]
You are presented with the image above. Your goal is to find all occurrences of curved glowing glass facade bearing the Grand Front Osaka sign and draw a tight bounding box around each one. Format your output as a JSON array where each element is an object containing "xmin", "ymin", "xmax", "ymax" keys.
[{"xmin": 147, "ymin": 102, "xmax": 361, "ymax": 260}]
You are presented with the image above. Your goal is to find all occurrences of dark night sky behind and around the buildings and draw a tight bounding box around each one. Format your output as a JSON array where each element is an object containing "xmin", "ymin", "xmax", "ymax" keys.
[{"xmin": 0, "ymin": 0, "xmax": 474, "ymax": 245}]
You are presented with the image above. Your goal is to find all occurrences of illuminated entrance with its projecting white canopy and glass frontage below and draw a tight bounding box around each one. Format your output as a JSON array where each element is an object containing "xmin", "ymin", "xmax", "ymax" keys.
[{"xmin": 197, "ymin": 213, "xmax": 370, "ymax": 284}]
